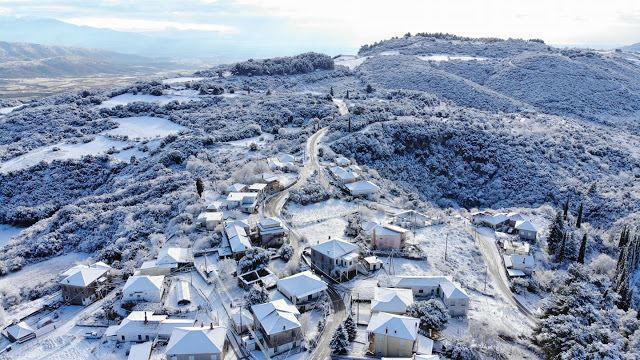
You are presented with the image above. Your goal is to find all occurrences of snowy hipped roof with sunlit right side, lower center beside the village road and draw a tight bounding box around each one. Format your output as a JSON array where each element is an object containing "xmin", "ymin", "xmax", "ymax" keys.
[{"xmin": 251, "ymin": 299, "xmax": 301, "ymax": 335}]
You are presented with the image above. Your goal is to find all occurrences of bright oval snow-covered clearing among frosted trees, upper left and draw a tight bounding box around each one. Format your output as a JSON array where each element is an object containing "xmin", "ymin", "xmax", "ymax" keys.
[{"xmin": 103, "ymin": 116, "xmax": 186, "ymax": 139}]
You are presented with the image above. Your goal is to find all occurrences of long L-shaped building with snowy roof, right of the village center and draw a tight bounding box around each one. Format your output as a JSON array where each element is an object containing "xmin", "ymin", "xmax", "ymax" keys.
[{"xmin": 385, "ymin": 276, "xmax": 469, "ymax": 316}]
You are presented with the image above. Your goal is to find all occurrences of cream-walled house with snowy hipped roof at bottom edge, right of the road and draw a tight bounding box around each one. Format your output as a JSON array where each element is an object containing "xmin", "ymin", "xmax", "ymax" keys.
[{"xmin": 367, "ymin": 312, "xmax": 420, "ymax": 358}]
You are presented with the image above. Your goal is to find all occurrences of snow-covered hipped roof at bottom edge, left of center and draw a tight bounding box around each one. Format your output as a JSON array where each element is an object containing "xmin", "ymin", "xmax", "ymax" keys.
[{"xmin": 165, "ymin": 326, "xmax": 227, "ymax": 355}]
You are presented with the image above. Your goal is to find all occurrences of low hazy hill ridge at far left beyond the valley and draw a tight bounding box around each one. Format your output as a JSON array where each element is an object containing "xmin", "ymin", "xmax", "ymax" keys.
[{"xmin": 0, "ymin": 41, "xmax": 188, "ymax": 79}]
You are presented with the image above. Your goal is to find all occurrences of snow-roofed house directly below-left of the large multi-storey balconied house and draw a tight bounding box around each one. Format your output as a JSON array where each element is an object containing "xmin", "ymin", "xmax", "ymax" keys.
[{"xmin": 276, "ymin": 270, "xmax": 327, "ymax": 310}]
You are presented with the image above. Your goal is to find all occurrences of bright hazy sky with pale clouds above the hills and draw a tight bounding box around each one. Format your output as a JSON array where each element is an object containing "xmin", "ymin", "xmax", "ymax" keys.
[{"xmin": 0, "ymin": 0, "xmax": 640, "ymax": 47}]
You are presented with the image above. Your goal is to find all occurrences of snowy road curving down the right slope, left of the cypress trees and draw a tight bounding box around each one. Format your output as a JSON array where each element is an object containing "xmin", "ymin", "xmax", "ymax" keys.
[{"xmin": 471, "ymin": 228, "xmax": 538, "ymax": 324}]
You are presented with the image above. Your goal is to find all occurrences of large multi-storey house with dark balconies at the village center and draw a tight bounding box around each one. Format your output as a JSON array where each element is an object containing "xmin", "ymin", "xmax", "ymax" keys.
[{"xmin": 311, "ymin": 239, "xmax": 359, "ymax": 281}]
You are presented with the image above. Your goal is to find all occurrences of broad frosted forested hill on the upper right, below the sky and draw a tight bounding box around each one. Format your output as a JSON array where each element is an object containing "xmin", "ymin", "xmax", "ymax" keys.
[{"xmin": 359, "ymin": 34, "xmax": 640, "ymax": 121}]
